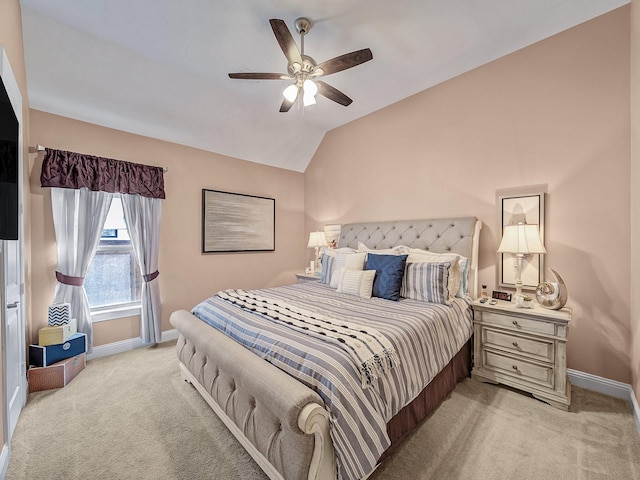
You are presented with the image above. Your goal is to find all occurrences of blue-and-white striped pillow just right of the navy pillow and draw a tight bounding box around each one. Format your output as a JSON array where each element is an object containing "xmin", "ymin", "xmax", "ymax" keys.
[{"xmin": 401, "ymin": 262, "xmax": 451, "ymax": 305}]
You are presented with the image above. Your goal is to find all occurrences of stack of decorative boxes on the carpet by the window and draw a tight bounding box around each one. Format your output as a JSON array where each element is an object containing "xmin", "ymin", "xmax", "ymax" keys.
[{"xmin": 28, "ymin": 303, "xmax": 87, "ymax": 392}]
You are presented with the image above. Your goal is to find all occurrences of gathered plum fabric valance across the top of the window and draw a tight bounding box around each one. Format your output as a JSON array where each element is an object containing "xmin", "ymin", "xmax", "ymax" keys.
[{"xmin": 40, "ymin": 148, "xmax": 165, "ymax": 199}]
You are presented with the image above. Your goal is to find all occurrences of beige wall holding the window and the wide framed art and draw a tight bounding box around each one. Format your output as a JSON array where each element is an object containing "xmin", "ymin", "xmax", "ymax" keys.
[{"xmin": 30, "ymin": 110, "xmax": 308, "ymax": 345}]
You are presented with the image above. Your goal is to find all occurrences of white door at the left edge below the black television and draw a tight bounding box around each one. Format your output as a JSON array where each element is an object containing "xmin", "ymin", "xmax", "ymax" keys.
[{"xmin": 2, "ymin": 240, "xmax": 27, "ymax": 439}]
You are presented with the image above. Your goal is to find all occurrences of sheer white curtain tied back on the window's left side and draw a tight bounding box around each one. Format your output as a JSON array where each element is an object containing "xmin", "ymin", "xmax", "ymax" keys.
[{"xmin": 51, "ymin": 188, "xmax": 113, "ymax": 352}]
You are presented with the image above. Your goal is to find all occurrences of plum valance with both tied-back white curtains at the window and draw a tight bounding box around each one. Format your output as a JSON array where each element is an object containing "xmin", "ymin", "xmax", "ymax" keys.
[{"xmin": 40, "ymin": 148, "xmax": 165, "ymax": 352}]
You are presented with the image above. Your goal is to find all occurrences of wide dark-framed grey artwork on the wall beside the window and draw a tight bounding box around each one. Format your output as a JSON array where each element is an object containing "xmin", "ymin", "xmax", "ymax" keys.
[{"xmin": 202, "ymin": 189, "xmax": 276, "ymax": 253}]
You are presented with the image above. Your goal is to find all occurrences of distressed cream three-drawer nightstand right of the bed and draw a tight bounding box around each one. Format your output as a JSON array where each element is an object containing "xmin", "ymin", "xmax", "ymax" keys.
[{"xmin": 471, "ymin": 300, "xmax": 571, "ymax": 410}]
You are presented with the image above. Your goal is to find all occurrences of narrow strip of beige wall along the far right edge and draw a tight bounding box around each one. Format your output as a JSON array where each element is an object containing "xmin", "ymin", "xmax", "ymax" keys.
[{"xmin": 631, "ymin": 0, "xmax": 640, "ymax": 403}]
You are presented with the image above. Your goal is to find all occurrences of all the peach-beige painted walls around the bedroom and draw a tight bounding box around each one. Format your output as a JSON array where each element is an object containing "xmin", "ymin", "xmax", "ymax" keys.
[{"xmin": 6, "ymin": 0, "xmax": 640, "ymax": 404}]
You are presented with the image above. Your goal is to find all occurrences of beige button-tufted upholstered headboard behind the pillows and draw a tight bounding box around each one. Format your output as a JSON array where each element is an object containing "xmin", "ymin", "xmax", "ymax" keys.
[{"xmin": 338, "ymin": 217, "xmax": 482, "ymax": 298}]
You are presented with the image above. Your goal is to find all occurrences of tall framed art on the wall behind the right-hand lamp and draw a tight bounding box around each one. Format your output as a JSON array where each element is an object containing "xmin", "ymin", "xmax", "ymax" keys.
[{"xmin": 496, "ymin": 185, "xmax": 546, "ymax": 290}]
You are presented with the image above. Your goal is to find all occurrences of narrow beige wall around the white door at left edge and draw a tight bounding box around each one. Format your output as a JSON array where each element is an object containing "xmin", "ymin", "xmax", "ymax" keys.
[{"xmin": 0, "ymin": 0, "xmax": 31, "ymax": 448}]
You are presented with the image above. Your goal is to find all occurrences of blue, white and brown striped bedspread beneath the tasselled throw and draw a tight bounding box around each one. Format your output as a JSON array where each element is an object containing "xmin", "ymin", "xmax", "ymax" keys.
[{"xmin": 192, "ymin": 282, "xmax": 472, "ymax": 480}]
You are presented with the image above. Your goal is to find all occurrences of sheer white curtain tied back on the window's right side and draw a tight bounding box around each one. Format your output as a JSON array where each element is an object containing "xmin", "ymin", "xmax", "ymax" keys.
[{"xmin": 121, "ymin": 194, "xmax": 162, "ymax": 343}]
